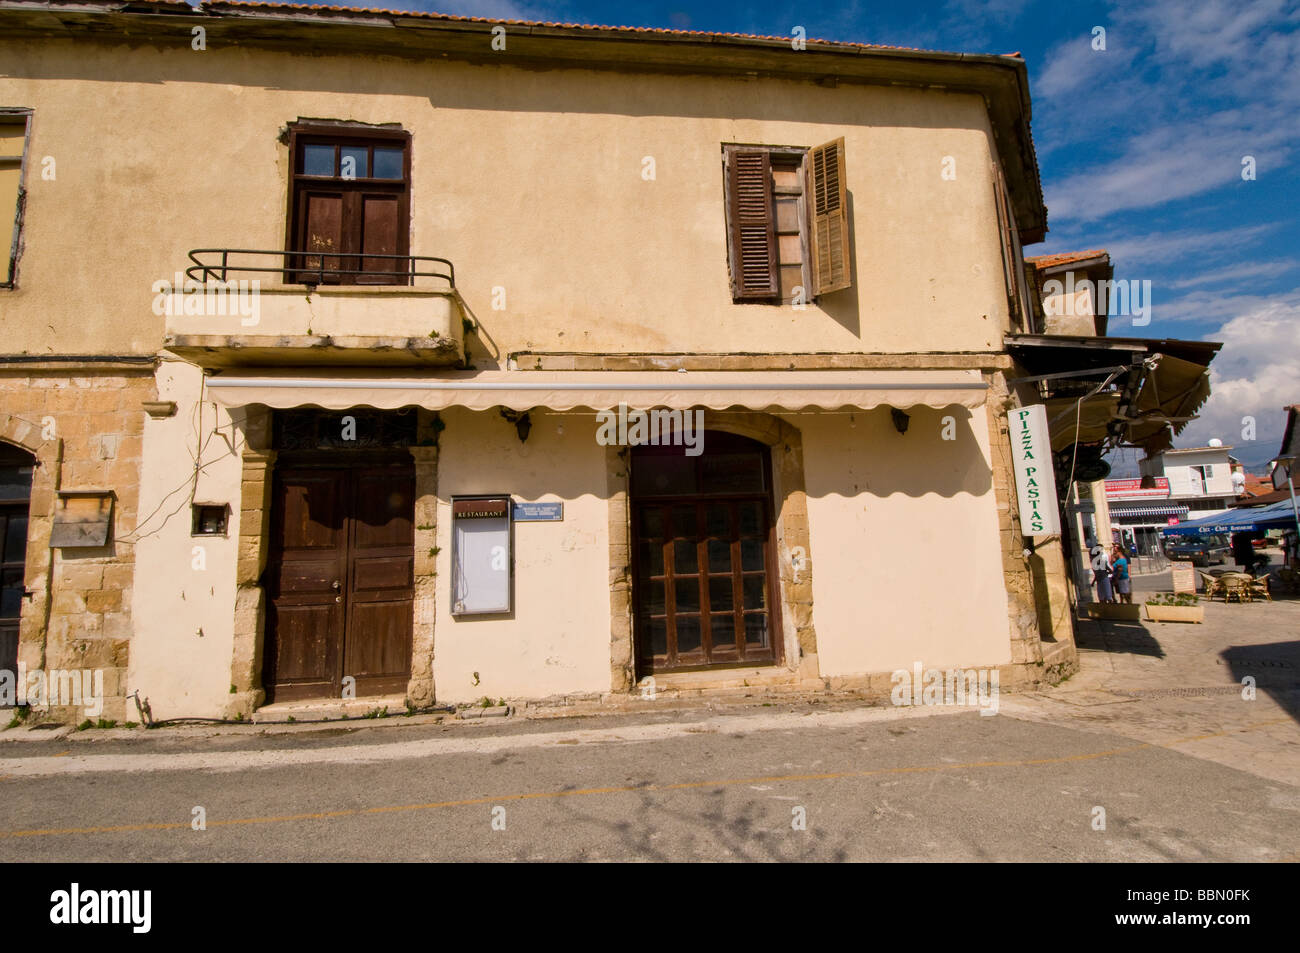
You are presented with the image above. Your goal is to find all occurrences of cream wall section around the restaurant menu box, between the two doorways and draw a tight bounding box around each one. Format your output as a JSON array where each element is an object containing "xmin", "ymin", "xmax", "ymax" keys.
[{"xmin": 433, "ymin": 410, "xmax": 610, "ymax": 702}]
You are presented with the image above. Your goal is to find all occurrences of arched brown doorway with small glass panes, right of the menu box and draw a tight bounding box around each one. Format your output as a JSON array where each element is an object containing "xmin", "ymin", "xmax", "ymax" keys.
[{"xmin": 631, "ymin": 430, "xmax": 781, "ymax": 677}]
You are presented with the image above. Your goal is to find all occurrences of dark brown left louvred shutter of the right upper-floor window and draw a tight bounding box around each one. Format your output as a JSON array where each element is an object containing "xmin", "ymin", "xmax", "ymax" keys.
[{"xmin": 727, "ymin": 150, "xmax": 779, "ymax": 300}]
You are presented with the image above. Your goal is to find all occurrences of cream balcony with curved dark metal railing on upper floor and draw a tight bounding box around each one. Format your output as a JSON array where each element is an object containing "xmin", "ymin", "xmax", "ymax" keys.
[{"xmin": 161, "ymin": 248, "xmax": 464, "ymax": 368}]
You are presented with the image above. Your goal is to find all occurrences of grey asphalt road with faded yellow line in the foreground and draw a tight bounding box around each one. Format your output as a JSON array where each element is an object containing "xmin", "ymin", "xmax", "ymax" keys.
[{"xmin": 0, "ymin": 705, "xmax": 1300, "ymax": 862}]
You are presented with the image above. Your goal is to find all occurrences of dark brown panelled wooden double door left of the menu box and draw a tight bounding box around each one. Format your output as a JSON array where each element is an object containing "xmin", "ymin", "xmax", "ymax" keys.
[{"xmin": 263, "ymin": 456, "xmax": 415, "ymax": 701}]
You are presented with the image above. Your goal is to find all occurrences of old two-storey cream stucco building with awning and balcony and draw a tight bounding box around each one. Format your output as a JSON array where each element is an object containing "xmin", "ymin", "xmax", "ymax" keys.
[{"xmin": 0, "ymin": 0, "xmax": 1073, "ymax": 718}]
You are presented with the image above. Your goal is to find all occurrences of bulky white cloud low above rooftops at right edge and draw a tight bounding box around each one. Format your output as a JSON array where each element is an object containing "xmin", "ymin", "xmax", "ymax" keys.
[{"xmin": 1177, "ymin": 289, "xmax": 1300, "ymax": 447}]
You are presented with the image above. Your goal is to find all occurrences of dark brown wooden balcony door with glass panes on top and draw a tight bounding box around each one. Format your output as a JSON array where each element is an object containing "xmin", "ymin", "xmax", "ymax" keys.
[{"xmin": 286, "ymin": 122, "xmax": 411, "ymax": 285}]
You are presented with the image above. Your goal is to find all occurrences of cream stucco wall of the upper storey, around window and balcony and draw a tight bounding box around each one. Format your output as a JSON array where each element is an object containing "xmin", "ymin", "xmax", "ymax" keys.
[{"xmin": 0, "ymin": 40, "xmax": 1006, "ymax": 360}]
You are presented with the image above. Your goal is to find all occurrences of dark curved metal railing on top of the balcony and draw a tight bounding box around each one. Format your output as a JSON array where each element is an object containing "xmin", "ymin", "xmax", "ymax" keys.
[{"xmin": 185, "ymin": 248, "xmax": 456, "ymax": 291}]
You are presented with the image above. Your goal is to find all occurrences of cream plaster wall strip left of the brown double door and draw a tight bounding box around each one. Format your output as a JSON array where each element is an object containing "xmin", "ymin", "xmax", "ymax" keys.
[{"xmin": 126, "ymin": 361, "xmax": 243, "ymax": 718}]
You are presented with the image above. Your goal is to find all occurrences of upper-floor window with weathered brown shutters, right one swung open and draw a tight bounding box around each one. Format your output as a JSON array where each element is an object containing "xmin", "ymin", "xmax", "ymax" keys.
[{"xmin": 723, "ymin": 139, "xmax": 853, "ymax": 304}]
